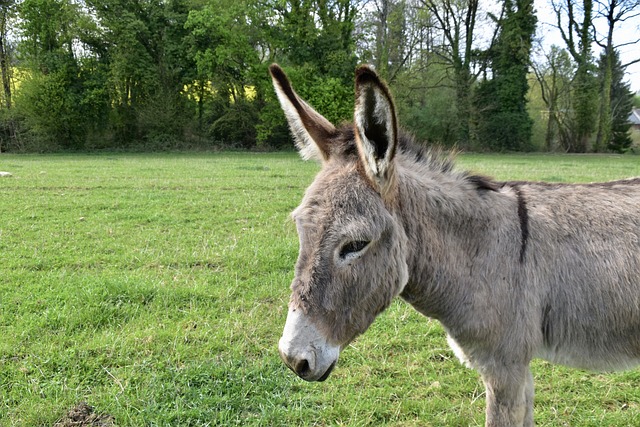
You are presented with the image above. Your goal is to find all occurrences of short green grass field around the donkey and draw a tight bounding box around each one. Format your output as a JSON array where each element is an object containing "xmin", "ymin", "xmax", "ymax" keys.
[{"xmin": 0, "ymin": 153, "xmax": 640, "ymax": 427}]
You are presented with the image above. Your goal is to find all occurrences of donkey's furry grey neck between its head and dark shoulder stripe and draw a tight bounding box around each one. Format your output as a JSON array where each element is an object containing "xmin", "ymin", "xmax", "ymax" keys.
[{"xmin": 398, "ymin": 160, "xmax": 520, "ymax": 326}]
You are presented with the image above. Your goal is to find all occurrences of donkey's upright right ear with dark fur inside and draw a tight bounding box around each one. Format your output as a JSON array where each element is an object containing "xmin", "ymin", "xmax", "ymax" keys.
[{"xmin": 354, "ymin": 65, "xmax": 398, "ymax": 193}]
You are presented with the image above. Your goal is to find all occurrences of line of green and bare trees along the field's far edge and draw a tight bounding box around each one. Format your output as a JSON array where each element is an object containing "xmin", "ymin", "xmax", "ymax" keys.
[{"xmin": 0, "ymin": 0, "xmax": 640, "ymax": 152}]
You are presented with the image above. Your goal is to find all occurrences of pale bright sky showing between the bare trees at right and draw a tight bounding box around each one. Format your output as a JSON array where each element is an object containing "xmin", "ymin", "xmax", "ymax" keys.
[{"xmin": 534, "ymin": 0, "xmax": 640, "ymax": 93}]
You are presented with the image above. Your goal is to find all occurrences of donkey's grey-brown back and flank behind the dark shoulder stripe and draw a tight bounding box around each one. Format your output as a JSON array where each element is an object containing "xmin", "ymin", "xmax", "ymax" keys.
[{"xmin": 519, "ymin": 179, "xmax": 640, "ymax": 370}]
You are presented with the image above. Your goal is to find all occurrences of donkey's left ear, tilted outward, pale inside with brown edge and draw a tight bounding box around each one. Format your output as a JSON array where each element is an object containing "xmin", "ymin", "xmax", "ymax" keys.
[{"xmin": 269, "ymin": 64, "xmax": 336, "ymax": 160}]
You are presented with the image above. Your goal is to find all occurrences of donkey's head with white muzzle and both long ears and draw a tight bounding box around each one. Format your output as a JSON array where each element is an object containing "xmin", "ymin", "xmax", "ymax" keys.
[{"xmin": 270, "ymin": 65, "xmax": 408, "ymax": 381}]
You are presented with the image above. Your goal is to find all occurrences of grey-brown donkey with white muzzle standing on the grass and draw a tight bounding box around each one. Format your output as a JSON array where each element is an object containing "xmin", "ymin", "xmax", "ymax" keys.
[{"xmin": 270, "ymin": 64, "xmax": 640, "ymax": 427}]
